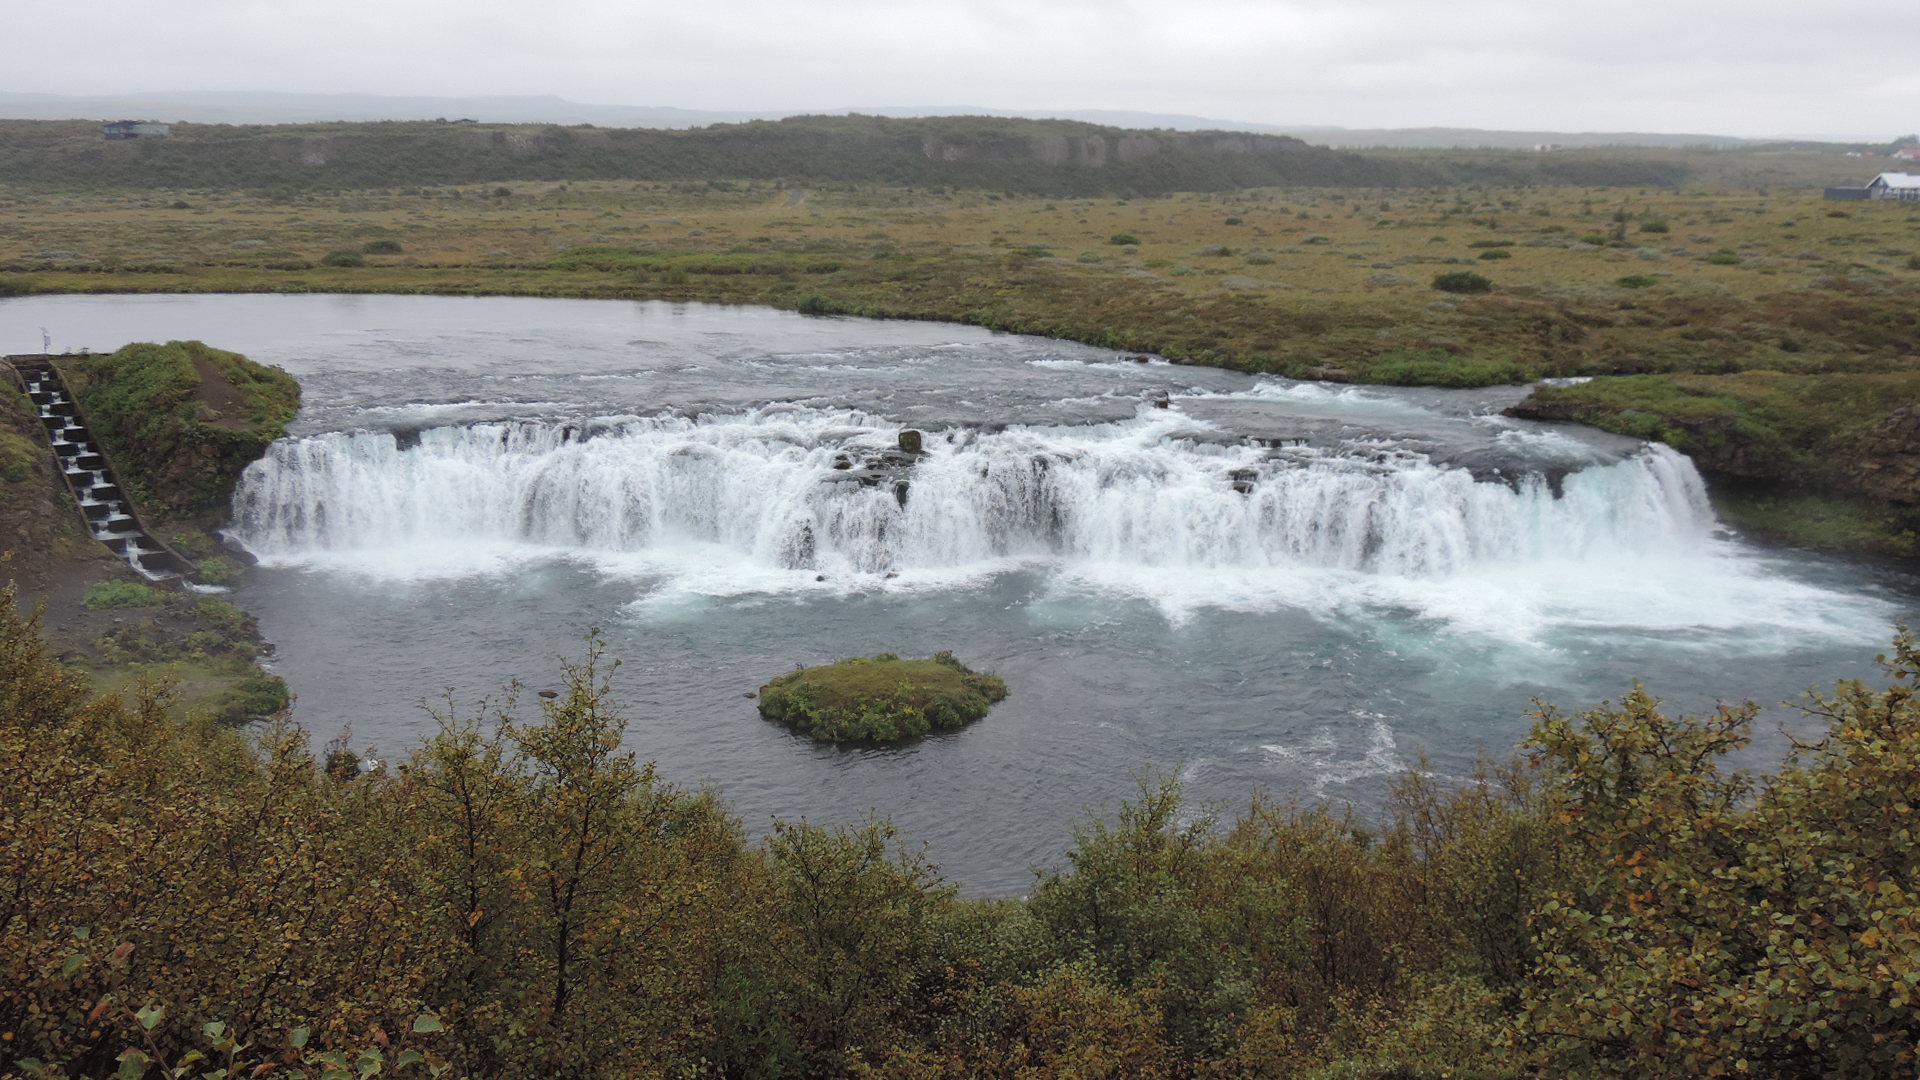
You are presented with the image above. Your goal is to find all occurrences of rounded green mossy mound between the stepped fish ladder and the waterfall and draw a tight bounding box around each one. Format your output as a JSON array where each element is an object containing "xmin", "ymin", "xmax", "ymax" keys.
[{"xmin": 67, "ymin": 342, "xmax": 300, "ymax": 517}]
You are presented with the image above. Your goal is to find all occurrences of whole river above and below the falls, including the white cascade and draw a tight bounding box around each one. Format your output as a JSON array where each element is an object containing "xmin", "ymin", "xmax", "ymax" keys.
[{"xmin": 0, "ymin": 296, "xmax": 1916, "ymax": 894}]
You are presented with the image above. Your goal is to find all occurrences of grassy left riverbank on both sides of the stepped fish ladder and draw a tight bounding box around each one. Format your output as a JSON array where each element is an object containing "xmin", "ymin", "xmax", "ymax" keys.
[{"xmin": 0, "ymin": 342, "xmax": 300, "ymax": 723}]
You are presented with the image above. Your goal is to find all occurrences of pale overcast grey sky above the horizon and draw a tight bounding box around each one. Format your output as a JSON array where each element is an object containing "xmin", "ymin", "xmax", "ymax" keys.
[{"xmin": 15, "ymin": 0, "xmax": 1920, "ymax": 136}]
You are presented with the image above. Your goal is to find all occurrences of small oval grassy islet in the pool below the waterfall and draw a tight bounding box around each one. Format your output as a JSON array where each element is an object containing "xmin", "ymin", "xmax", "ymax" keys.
[{"xmin": 760, "ymin": 651, "xmax": 1006, "ymax": 742}]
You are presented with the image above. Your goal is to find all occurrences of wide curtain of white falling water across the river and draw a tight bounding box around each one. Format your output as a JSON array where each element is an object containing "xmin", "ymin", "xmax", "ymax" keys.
[{"xmin": 232, "ymin": 407, "xmax": 1713, "ymax": 577}]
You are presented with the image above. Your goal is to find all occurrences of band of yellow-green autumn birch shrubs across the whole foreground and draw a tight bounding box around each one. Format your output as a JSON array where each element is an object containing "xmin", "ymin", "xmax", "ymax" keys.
[{"xmin": 0, "ymin": 580, "xmax": 1920, "ymax": 1080}]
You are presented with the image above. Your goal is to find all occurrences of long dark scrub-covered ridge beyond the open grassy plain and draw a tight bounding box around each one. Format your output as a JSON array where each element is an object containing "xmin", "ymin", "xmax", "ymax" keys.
[{"xmin": 0, "ymin": 115, "xmax": 1432, "ymax": 196}]
